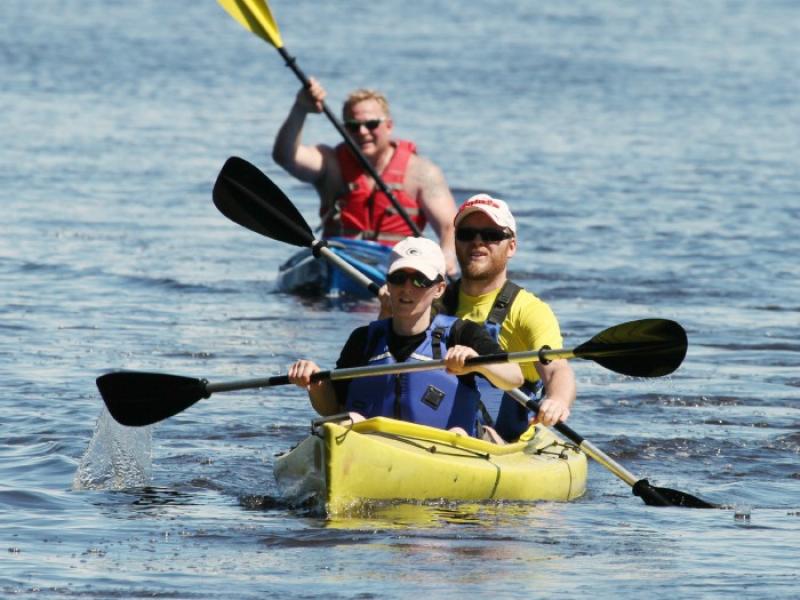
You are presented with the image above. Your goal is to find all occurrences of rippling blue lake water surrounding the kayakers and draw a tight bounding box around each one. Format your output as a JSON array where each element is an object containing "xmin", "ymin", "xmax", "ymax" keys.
[{"xmin": 0, "ymin": 0, "xmax": 800, "ymax": 599}]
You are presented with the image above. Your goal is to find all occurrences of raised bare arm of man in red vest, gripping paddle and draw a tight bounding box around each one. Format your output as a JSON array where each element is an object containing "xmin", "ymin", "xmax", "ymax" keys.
[{"xmin": 272, "ymin": 78, "xmax": 326, "ymax": 183}]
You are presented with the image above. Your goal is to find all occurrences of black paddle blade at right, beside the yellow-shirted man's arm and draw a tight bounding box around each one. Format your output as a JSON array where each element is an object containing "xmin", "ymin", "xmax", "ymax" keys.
[{"xmin": 574, "ymin": 319, "xmax": 688, "ymax": 377}]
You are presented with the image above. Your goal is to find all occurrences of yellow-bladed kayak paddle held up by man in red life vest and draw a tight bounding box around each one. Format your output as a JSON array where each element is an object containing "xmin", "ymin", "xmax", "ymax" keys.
[{"xmin": 218, "ymin": 0, "xmax": 422, "ymax": 237}]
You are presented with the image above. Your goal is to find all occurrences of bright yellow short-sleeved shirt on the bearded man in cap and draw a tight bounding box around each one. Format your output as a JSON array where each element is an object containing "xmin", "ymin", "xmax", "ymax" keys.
[{"xmin": 456, "ymin": 288, "xmax": 564, "ymax": 381}]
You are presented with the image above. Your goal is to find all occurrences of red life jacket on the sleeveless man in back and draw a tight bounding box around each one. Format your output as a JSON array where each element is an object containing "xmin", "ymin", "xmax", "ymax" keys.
[{"xmin": 325, "ymin": 140, "xmax": 427, "ymax": 246}]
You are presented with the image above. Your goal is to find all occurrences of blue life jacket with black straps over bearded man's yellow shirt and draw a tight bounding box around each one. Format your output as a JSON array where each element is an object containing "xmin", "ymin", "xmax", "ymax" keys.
[{"xmin": 444, "ymin": 280, "xmax": 544, "ymax": 441}]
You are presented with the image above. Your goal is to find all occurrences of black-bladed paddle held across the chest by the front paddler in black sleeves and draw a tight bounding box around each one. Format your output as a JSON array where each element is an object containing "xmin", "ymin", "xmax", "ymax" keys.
[{"xmin": 97, "ymin": 319, "xmax": 687, "ymax": 427}]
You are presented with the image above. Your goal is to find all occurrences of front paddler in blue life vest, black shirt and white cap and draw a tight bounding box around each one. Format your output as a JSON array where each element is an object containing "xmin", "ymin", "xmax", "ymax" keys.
[{"xmin": 288, "ymin": 237, "xmax": 523, "ymax": 435}]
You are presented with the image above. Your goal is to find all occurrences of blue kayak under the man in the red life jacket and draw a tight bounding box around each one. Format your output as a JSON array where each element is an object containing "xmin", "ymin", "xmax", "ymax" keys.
[{"xmin": 276, "ymin": 237, "xmax": 392, "ymax": 298}]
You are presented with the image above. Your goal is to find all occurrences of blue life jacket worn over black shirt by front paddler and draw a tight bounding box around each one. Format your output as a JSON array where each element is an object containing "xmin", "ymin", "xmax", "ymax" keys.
[{"xmin": 345, "ymin": 315, "xmax": 479, "ymax": 436}]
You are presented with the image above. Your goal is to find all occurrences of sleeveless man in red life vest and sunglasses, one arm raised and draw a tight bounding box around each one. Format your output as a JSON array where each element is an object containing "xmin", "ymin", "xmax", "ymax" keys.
[{"xmin": 272, "ymin": 78, "xmax": 456, "ymax": 274}]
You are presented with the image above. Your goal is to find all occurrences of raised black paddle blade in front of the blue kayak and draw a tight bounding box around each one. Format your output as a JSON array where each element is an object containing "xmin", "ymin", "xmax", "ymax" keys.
[{"xmin": 213, "ymin": 156, "xmax": 314, "ymax": 248}]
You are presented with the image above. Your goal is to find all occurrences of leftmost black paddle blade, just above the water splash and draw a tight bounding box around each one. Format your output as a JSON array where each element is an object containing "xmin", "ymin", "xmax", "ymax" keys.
[{"xmin": 97, "ymin": 371, "xmax": 209, "ymax": 427}]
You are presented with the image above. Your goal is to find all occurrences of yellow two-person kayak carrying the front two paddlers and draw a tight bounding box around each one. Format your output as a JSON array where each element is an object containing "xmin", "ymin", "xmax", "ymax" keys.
[{"xmin": 275, "ymin": 417, "xmax": 587, "ymax": 514}]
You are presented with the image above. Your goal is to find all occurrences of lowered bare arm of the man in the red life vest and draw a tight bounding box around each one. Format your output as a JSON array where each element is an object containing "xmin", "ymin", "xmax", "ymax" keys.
[{"xmin": 414, "ymin": 156, "xmax": 458, "ymax": 275}]
